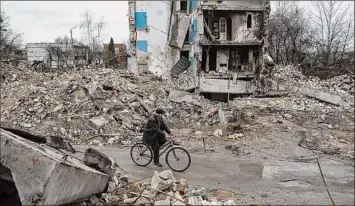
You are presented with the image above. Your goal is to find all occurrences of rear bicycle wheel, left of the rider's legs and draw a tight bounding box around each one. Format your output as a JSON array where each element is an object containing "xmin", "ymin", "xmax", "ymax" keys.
[{"xmin": 131, "ymin": 142, "xmax": 153, "ymax": 167}]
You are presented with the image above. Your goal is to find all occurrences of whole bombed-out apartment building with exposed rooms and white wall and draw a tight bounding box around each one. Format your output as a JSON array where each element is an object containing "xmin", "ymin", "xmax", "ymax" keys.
[{"xmin": 128, "ymin": 0, "xmax": 270, "ymax": 100}]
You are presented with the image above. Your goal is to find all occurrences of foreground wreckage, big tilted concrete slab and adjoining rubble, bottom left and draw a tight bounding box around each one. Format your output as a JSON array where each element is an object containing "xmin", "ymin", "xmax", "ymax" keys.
[{"xmin": 0, "ymin": 128, "xmax": 235, "ymax": 205}]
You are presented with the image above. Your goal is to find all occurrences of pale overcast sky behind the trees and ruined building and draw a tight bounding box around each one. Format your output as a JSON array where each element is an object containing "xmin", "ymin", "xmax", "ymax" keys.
[{"xmin": 1, "ymin": 1, "xmax": 354, "ymax": 46}]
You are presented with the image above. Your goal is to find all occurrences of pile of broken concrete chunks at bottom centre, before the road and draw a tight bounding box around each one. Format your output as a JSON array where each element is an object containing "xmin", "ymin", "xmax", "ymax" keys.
[{"xmin": 83, "ymin": 170, "xmax": 235, "ymax": 205}]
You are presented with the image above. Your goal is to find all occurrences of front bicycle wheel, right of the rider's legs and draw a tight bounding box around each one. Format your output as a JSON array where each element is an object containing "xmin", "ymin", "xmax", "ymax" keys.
[{"xmin": 165, "ymin": 147, "xmax": 191, "ymax": 172}]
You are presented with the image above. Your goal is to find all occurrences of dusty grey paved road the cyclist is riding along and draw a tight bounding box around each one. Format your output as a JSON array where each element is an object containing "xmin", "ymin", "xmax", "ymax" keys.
[{"xmin": 77, "ymin": 146, "xmax": 354, "ymax": 205}]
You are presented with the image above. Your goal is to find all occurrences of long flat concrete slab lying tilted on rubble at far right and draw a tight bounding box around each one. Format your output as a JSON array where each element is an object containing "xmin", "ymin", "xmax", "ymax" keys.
[{"xmin": 298, "ymin": 87, "xmax": 343, "ymax": 106}]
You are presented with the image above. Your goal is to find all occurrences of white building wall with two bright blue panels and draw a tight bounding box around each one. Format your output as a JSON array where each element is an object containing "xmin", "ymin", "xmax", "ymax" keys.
[{"xmin": 128, "ymin": 1, "xmax": 179, "ymax": 76}]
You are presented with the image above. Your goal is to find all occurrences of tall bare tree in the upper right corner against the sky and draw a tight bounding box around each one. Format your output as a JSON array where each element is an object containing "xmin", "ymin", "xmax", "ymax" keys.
[{"xmin": 312, "ymin": 1, "xmax": 354, "ymax": 66}]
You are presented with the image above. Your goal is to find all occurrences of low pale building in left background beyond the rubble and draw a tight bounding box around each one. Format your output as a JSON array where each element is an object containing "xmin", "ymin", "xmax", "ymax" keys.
[{"xmin": 26, "ymin": 43, "xmax": 89, "ymax": 69}]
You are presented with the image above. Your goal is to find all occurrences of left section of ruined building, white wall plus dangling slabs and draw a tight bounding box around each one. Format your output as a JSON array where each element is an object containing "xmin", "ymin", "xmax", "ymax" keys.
[{"xmin": 128, "ymin": 1, "xmax": 198, "ymax": 77}]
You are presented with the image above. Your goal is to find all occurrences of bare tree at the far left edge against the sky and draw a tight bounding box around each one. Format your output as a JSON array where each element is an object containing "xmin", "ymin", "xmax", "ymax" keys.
[{"xmin": 0, "ymin": 11, "xmax": 23, "ymax": 60}]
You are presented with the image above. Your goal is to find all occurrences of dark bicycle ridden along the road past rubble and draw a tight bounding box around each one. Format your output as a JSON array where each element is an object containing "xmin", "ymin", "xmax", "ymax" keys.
[{"xmin": 131, "ymin": 140, "xmax": 191, "ymax": 172}]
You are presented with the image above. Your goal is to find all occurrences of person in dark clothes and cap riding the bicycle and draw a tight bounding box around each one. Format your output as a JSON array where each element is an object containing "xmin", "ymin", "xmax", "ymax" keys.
[{"xmin": 143, "ymin": 108, "xmax": 171, "ymax": 167}]
